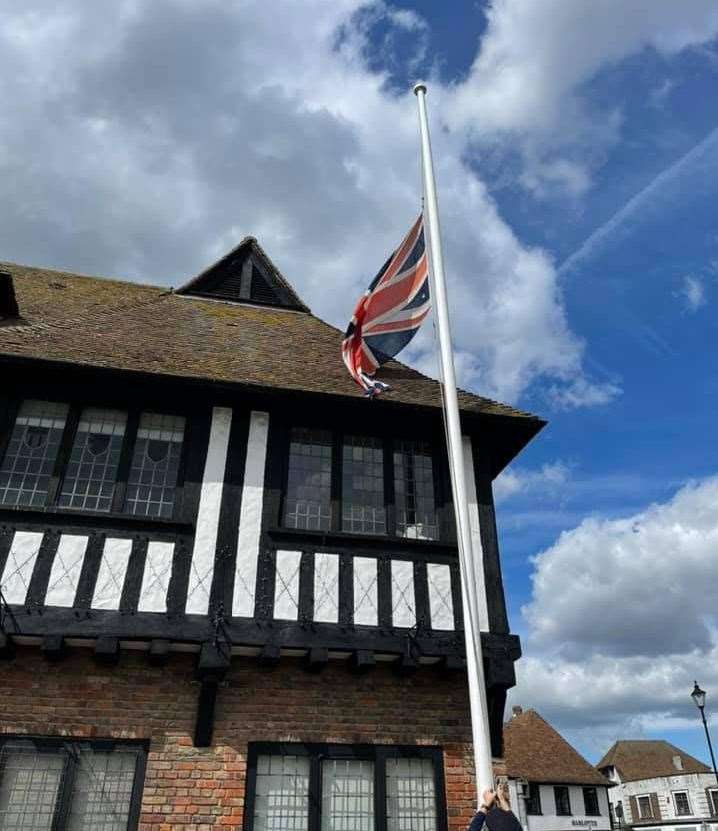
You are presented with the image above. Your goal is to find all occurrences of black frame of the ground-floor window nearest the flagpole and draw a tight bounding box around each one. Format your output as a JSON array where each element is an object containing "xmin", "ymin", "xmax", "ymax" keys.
[{"xmin": 248, "ymin": 742, "xmax": 448, "ymax": 831}]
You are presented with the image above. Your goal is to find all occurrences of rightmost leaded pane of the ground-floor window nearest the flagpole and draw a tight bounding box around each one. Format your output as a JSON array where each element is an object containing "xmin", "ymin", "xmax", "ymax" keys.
[{"xmin": 386, "ymin": 758, "xmax": 437, "ymax": 831}]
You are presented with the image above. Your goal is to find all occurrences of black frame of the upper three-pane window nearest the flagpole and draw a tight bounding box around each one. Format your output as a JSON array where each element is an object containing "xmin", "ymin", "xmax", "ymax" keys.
[{"xmin": 275, "ymin": 416, "xmax": 456, "ymax": 545}]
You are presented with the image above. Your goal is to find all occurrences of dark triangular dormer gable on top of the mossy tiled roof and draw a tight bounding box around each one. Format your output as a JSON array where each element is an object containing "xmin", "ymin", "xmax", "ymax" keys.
[{"xmin": 175, "ymin": 237, "xmax": 309, "ymax": 312}]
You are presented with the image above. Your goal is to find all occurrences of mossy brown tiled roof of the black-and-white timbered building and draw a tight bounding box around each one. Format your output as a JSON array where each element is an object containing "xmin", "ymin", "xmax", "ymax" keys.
[{"xmin": 0, "ymin": 263, "xmax": 543, "ymax": 422}]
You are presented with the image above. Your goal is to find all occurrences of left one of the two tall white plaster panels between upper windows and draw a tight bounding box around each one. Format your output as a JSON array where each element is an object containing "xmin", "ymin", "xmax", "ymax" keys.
[{"xmin": 185, "ymin": 407, "xmax": 232, "ymax": 615}]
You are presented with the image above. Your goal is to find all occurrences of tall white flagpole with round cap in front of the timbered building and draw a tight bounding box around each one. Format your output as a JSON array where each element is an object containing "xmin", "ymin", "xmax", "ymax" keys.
[{"xmin": 414, "ymin": 83, "xmax": 494, "ymax": 801}]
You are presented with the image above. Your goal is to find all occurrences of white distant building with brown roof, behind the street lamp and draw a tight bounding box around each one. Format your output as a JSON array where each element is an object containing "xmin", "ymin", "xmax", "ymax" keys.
[{"xmin": 597, "ymin": 740, "xmax": 718, "ymax": 831}]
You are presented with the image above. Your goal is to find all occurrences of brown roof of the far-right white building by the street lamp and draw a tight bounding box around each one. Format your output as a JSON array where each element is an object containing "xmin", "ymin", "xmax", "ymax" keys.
[{"xmin": 596, "ymin": 739, "xmax": 711, "ymax": 782}]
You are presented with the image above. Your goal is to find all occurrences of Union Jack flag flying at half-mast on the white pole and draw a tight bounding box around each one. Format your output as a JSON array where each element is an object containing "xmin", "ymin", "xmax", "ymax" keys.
[{"xmin": 342, "ymin": 214, "xmax": 431, "ymax": 397}]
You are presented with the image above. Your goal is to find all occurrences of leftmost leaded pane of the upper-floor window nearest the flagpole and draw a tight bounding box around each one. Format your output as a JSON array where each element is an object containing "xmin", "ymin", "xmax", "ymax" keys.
[{"xmin": 284, "ymin": 427, "xmax": 332, "ymax": 531}]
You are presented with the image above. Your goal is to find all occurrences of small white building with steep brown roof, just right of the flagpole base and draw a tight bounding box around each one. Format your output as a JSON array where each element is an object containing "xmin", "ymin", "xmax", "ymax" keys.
[{"xmin": 504, "ymin": 707, "xmax": 611, "ymax": 831}]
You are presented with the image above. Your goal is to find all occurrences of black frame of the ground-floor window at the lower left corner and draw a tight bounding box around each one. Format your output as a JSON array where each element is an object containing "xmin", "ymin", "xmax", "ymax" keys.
[{"xmin": 0, "ymin": 733, "xmax": 149, "ymax": 831}]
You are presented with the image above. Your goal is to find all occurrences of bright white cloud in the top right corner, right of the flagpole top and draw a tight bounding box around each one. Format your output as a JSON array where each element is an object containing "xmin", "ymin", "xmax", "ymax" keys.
[{"xmin": 447, "ymin": 0, "xmax": 718, "ymax": 193}]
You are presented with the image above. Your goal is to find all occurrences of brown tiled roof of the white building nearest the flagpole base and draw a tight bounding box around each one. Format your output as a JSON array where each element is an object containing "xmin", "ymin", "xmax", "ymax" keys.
[{"xmin": 504, "ymin": 710, "xmax": 610, "ymax": 786}]
